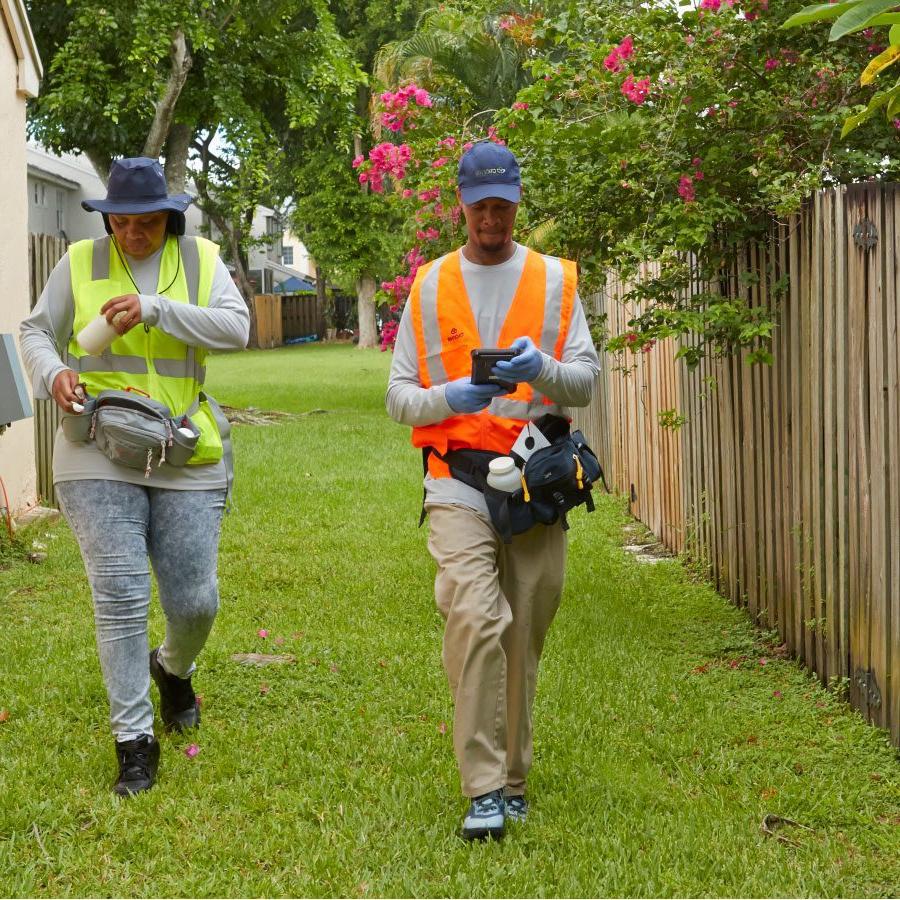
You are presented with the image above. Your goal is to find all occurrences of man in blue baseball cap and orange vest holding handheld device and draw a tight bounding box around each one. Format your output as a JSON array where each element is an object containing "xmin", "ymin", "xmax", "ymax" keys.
[{"xmin": 387, "ymin": 141, "xmax": 599, "ymax": 840}]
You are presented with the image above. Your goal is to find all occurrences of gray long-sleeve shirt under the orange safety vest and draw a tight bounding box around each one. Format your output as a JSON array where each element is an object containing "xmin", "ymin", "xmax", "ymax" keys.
[{"xmin": 386, "ymin": 244, "xmax": 600, "ymax": 516}]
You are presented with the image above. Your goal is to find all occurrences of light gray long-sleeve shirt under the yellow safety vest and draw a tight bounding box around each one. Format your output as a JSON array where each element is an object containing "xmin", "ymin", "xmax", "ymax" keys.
[{"xmin": 20, "ymin": 239, "xmax": 250, "ymax": 490}]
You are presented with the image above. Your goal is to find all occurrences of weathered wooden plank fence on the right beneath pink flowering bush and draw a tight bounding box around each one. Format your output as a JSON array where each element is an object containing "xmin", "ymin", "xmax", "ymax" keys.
[{"xmin": 576, "ymin": 183, "xmax": 900, "ymax": 744}]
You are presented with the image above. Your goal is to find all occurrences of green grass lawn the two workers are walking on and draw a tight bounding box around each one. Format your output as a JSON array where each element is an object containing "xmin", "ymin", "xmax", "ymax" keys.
[{"xmin": 0, "ymin": 346, "xmax": 900, "ymax": 897}]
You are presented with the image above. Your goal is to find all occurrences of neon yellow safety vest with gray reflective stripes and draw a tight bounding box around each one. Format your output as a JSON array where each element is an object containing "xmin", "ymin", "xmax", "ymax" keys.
[{"xmin": 66, "ymin": 234, "xmax": 223, "ymax": 465}]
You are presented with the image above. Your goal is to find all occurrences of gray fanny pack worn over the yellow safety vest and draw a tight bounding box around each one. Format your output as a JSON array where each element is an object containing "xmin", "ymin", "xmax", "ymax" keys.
[{"xmin": 62, "ymin": 390, "xmax": 203, "ymax": 482}]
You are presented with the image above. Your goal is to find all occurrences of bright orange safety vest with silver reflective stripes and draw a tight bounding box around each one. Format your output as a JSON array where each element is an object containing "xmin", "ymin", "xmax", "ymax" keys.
[{"xmin": 409, "ymin": 239, "xmax": 578, "ymax": 478}]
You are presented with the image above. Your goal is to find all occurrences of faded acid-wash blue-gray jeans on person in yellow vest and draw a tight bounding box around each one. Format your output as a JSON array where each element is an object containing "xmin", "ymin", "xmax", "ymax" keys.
[{"xmin": 56, "ymin": 479, "xmax": 225, "ymax": 741}]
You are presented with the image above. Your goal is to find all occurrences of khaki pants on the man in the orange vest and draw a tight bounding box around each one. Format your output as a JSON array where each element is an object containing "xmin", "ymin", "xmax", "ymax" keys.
[{"xmin": 428, "ymin": 504, "xmax": 566, "ymax": 797}]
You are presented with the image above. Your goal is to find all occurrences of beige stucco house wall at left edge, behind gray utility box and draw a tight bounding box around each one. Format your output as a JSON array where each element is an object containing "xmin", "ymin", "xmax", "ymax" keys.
[{"xmin": 0, "ymin": 15, "xmax": 37, "ymax": 513}]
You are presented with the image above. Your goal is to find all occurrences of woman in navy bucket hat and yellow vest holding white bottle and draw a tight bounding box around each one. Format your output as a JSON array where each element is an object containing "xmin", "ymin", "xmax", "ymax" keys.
[{"xmin": 21, "ymin": 157, "xmax": 250, "ymax": 796}]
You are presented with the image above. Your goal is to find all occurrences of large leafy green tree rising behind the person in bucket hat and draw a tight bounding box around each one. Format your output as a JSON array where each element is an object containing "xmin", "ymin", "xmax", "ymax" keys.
[{"xmin": 29, "ymin": 0, "xmax": 361, "ymax": 293}]
